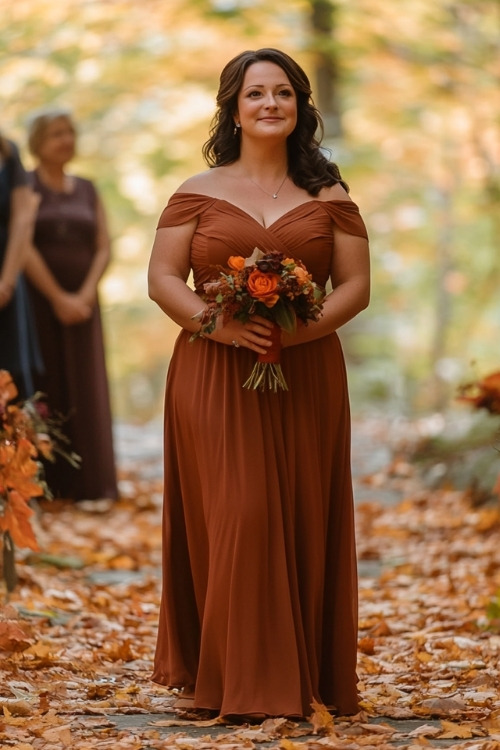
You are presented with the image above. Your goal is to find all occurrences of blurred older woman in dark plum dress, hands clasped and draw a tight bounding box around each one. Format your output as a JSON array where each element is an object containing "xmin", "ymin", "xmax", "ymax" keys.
[{"xmin": 26, "ymin": 110, "xmax": 118, "ymax": 500}]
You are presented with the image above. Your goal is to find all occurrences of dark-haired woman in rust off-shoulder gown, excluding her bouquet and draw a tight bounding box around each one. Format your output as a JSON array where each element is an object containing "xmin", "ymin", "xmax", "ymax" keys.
[{"xmin": 149, "ymin": 49, "xmax": 369, "ymax": 719}]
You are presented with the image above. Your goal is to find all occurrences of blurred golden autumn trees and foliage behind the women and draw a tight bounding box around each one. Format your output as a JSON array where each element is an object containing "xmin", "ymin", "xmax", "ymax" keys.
[{"xmin": 0, "ymin": 0, "xmax": 500, "ymax": 419}]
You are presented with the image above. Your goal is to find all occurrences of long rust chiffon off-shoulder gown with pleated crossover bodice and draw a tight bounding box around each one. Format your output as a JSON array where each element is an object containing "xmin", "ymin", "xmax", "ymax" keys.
[{"xmin": 153, "ymin": 193, "xmax": 366, "ymax": 716}]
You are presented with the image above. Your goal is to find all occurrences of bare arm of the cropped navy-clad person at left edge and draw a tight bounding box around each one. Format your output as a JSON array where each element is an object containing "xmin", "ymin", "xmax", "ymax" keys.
[{"xmin": 0, "ymin": 185, "xmax": 40, "ymax": 308}]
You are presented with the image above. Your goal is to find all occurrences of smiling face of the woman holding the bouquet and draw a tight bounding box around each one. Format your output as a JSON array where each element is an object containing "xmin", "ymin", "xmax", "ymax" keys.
[{"xmin": 234, "ymin": 61, "xmax": 297, "ymax": 140}]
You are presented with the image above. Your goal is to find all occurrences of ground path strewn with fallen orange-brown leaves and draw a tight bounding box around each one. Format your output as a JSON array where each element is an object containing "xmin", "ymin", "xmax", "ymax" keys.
[{"xmin": 0, "ymin": 420, "xmax": 500, "ymax": 750}]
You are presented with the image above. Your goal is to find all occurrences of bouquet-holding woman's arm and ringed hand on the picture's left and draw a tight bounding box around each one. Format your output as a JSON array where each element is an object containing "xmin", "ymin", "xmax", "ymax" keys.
[{"xmin": 148, "ymin": 219, "xmax": 271, "ymax": 353}]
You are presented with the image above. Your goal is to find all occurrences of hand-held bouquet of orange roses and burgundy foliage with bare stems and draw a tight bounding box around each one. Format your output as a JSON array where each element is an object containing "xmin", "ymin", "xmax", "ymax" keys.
[{"xmin": 191, "ymin": 247, "xmax": 325, "ymax": 392}]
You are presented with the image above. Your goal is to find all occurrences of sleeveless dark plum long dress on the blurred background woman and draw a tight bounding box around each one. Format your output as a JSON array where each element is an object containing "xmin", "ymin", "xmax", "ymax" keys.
[{"xmin": 30, "ymin": 172, "xmax": 118, "ymax": 500}]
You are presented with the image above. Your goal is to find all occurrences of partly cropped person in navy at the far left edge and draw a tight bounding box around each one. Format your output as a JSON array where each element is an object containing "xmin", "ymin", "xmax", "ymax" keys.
[{"xmin": 0, "ymin": 133, "xmax": 42, "ymax": 398}]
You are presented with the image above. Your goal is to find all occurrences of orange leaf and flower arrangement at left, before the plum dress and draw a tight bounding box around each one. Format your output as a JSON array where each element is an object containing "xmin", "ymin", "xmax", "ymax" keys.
[{"xmin": 0, "ymin": 370, "xmax": 79, "ymax": 590}]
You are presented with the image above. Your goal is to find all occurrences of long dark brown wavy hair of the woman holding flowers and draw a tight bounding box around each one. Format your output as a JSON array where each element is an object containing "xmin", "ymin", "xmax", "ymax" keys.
[{"xmin": 203, "ymin": 47, "xmax": 349, "ymax": 195}]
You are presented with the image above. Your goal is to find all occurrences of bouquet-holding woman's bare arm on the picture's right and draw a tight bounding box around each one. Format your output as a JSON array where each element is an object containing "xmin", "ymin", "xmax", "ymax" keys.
[{"xmin": 282, "ymin": 228, "xmax": 370, "ymax": 346}]
